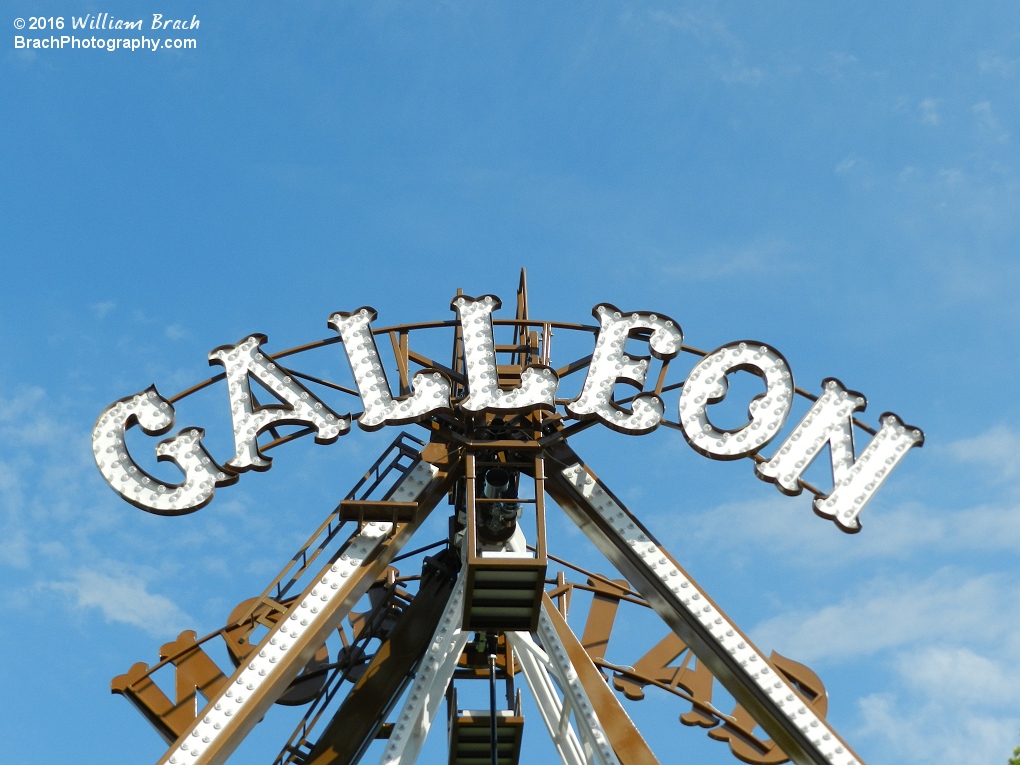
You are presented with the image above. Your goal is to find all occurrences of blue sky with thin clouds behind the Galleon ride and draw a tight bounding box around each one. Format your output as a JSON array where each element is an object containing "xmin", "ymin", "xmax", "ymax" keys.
[{"xmin": 0, "ymin": 0, "xmax": 1020, "ymax": 765}]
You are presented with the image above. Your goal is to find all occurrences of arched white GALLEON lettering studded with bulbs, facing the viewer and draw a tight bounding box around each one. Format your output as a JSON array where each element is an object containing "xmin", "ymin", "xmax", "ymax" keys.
[{"xmin": 93, "ymin": 295, "xmax": 924, "ymax": 532}]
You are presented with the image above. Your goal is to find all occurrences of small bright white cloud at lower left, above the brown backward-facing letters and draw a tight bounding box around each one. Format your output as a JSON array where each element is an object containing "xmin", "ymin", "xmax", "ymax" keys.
[{"xmin": 43, "ymin": 569, "xmax": 192, "ymax": 636}]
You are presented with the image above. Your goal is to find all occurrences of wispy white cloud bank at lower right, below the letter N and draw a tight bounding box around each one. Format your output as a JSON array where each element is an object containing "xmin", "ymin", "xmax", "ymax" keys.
[{"xmin": 651, "ymin": 426, "xmax": 1020, "ymax": 765}]
